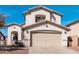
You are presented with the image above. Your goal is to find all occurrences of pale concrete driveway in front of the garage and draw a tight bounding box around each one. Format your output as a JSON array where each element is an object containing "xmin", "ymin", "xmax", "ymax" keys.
[{"xmin": 29, "ymin": 47, "xmax": 79, "ymax": 54}]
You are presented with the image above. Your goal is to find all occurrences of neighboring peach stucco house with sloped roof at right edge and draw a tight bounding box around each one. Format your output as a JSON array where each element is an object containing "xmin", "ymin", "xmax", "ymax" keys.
[{"xmin": 66, "ymin": 20, "xmax": 79, "ymax": 46}]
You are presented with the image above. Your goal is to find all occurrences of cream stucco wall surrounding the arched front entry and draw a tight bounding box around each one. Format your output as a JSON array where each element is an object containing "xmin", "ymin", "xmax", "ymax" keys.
[{"xmin": 6, "ymin": 25, "xmax": 22, "ymax": 45}]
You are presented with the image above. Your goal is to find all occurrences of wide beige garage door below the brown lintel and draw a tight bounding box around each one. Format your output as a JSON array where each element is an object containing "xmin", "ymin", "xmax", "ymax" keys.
[{"xmin": 32, "ymin": 33, "xmax": 61, "ymax": 47}]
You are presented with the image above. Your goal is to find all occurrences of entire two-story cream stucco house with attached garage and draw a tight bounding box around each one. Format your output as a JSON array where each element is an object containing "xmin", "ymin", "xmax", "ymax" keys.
[{"xmin": 6, "ymin": 6, "xmax": 70, "ymax": 48}]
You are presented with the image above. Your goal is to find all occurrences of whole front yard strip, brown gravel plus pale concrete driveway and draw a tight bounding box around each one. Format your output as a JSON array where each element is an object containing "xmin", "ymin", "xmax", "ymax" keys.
[{"xmin": 0, "ymin": 47, "xmax": 79, "ymax": 54}]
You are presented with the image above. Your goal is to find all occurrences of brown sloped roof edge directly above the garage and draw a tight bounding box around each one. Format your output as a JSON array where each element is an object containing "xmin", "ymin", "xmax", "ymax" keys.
[{"xmin": 22, "ymin": 21, "xmax": 70, "ymax": 31}]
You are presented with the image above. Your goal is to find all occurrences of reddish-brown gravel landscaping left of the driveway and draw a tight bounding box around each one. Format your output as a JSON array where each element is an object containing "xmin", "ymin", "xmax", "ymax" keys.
[{"xmin": 0, "ymin": 47, "xmax": 29, "ymax": 54}]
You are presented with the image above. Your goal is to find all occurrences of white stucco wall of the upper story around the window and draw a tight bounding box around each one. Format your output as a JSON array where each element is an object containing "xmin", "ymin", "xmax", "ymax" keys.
[{"xmin": 25, "ymin": 10, "xmax": 61, "ymax": 25}]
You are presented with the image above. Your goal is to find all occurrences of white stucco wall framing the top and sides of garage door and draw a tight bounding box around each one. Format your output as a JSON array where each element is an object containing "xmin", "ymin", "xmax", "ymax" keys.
[{"xmin": 24, "ymin": 24, "xmax": 67, "ymax": 46}]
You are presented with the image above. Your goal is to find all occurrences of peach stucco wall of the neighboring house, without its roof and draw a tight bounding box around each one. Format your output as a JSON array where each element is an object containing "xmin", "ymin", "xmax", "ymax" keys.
[{"xmin": 68, "ymin": 23, "xmax": 79, "ymax": 46}]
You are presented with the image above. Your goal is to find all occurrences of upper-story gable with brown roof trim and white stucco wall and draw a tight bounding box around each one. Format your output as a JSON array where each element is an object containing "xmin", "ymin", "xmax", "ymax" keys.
[{"xmin": 24, "ymin": 6, "xmax": 62, "ymax": 25}]
